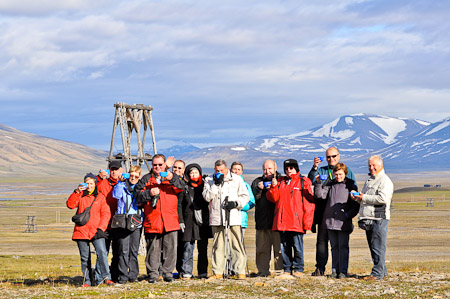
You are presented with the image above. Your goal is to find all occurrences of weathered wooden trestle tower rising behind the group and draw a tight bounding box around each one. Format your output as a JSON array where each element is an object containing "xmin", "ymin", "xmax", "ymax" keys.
[{"xmin": 106, "ymin": 103, "xmax": 157, "ymax": 172}]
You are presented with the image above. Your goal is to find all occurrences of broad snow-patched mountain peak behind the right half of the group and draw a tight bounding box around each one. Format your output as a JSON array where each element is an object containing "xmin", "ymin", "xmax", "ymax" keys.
[{"xmin": 248, "ymin": 114, "xmax": 429, "ymax": 156}]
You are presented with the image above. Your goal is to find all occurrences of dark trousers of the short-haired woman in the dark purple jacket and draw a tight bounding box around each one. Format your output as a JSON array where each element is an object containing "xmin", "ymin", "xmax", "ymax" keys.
[{"xmin": 328, "ymin": 230, "xmax": 350, "ymax": 275}]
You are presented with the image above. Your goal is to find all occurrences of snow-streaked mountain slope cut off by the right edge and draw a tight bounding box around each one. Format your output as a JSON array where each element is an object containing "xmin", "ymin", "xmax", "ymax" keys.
[{"xmin": 380, "ymin": 117, "xmax": 450, "ymax": 171}]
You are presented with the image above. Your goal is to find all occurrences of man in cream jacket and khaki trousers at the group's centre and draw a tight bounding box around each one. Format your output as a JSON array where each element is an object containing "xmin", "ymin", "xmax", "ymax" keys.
[{"xmin": 203, "ymin": 160, "xmax": 249, "ymax": 280}]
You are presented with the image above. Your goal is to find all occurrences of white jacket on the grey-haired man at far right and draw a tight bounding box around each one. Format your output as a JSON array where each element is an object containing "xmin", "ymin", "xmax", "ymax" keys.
[{"xmin": 359, "ymin": 169, "xmax": 394, "ymax": 220}]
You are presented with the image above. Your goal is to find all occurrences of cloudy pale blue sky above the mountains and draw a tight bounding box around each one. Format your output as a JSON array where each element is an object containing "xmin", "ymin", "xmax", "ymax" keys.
[{"xmin": 0, "ymin": 0, "xmax": 450, "ymax": 150}]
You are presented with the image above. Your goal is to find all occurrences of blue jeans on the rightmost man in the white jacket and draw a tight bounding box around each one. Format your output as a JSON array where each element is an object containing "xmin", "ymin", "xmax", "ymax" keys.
[{"xmin": 366, "ymin": 219, "xmax": 389, "ymax": 279}]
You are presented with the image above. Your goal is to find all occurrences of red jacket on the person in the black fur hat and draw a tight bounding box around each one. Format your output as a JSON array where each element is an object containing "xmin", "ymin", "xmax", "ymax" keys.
[{"xmin": 267, "ymin": 173, "xmax": 315, "ymax": 233}]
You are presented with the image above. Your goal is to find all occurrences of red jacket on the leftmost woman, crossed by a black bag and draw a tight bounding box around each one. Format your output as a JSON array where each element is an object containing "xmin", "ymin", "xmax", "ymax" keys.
[{"xmin": 67, "ymin": 190, "xmax": 111, "ymax": 240}]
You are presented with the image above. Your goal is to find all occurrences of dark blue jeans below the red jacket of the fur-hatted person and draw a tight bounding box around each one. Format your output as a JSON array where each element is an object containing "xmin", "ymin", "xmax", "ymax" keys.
[{"xmin": 280, "ymin": 232, "xmax": 305, "ymax": 273}]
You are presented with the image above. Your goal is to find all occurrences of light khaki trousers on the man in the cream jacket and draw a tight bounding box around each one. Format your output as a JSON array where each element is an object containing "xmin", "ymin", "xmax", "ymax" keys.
[{"xmin": 211, "ymin": 225, "xmax": 247, "ymax": 275}]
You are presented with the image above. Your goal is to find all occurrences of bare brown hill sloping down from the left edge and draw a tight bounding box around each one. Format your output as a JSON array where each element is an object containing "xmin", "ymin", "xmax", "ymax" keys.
[{"xmin": 0, "ymin": 124, "xmax": 107, "ymax": 177}]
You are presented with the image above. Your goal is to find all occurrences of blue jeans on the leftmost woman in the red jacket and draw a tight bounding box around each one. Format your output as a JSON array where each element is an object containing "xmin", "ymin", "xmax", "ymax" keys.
[{"xmin": 76, "ymin": 239, "xmax": 111, "ymax": 285}]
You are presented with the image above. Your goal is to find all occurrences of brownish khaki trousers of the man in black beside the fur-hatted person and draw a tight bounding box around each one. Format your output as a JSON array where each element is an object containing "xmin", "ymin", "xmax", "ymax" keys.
[{"xmin": 256, "ymin": 229, "xmax": 283, "ymax": 275}]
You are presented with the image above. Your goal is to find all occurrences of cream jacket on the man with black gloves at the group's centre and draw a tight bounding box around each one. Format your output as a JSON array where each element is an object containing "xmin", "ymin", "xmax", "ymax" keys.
[{"xmin": 202, "ymin": 171, "xmax": 250, "ymax": 226}]
